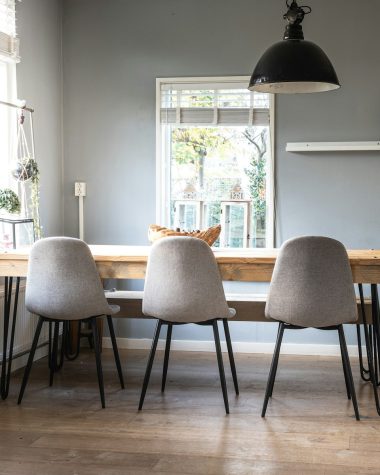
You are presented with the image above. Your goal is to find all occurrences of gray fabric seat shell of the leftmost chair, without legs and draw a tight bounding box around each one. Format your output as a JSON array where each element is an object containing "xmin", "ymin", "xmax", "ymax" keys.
[{"xmin": 25, "ymin": 237, "xmax": 113, "ymax": 320}]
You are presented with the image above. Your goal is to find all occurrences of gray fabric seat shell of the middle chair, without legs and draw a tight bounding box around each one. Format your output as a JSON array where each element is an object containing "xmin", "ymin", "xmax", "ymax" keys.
[{"xmin": 143, "ymin": 236, "xmax": 230, "ymax": 323}]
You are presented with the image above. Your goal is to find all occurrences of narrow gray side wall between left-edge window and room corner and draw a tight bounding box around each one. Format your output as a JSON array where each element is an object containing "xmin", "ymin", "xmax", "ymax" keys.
[{"xmin": 16, "ymin": 0, "xmax": 63, "ymax": 236}]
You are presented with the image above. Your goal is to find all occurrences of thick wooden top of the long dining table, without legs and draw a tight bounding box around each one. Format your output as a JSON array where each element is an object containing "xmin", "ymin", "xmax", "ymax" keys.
[{"xmin": 0, "ymin": 245, "xmax": 380, "ymax": 283}]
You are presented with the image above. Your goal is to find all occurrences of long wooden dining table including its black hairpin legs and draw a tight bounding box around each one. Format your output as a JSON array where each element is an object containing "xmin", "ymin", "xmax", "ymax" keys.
[{"xmin": 0, "ymin": 245, "xmax": 380, "ymax": 414}]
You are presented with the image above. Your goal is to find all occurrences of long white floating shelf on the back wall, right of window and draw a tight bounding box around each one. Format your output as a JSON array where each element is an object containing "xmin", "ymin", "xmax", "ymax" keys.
[{"xmin": 286, "ymin": 141, "xmax": 380, "ymax": 152}]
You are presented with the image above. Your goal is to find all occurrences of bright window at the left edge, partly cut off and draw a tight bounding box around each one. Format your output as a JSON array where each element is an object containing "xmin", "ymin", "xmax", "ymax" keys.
[{"xmin": 0, "ymin": 0, "xmax": 19, "ymax": 188}]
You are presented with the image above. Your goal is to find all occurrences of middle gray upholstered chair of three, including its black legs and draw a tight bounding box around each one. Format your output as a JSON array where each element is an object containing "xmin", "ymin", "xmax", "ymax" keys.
[{"xmin": 139, "ymin": 237, "xmax": 239, "ymax": 414}]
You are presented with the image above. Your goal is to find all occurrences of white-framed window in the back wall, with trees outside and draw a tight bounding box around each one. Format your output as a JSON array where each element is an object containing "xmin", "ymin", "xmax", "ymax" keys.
[{"xmin": 157, "ymin": 77, "xmax": 274, "ymax": 248}]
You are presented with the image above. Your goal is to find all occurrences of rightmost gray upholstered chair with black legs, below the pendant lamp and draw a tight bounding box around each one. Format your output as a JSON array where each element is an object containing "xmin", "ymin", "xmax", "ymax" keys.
[{"xmin": 261, "ymin": 236, "xmax": 359, "ymax": 420}]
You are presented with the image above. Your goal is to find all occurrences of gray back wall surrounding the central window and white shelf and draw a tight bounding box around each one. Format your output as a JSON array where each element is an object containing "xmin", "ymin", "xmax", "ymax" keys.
[{"xmin": 58, "ymin": 0, "xmax": 380, "ymax": 342}]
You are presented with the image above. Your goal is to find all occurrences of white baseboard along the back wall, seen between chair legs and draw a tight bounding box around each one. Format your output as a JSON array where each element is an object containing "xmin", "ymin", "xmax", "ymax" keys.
[{"xmin": 103, "ymin": 337, "xmax": 365, "ymax": 356}]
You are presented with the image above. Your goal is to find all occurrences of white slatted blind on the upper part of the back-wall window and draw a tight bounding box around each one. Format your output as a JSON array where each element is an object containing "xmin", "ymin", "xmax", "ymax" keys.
[{"xmin": 160, "ymin": 82, "xmax": 269, "ymax": 126}]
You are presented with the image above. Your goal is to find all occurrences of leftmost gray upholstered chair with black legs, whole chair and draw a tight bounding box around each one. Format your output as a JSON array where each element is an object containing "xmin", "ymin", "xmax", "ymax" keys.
[{"xmin": 18, "ymin": 237, "xmax": 124, "ymax": 407}]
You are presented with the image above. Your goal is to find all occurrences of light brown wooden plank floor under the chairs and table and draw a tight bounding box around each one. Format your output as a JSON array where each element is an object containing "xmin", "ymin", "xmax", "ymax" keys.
[{"xmin": 0, "ymin": 350, "xmax": 380, "ymax": 475}]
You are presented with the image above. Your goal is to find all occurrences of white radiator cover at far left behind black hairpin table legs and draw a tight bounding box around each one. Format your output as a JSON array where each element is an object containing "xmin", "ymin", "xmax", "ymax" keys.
[{"xmin": 0, "ymin": 279, "xmax": 49, "ymax": 370}]
